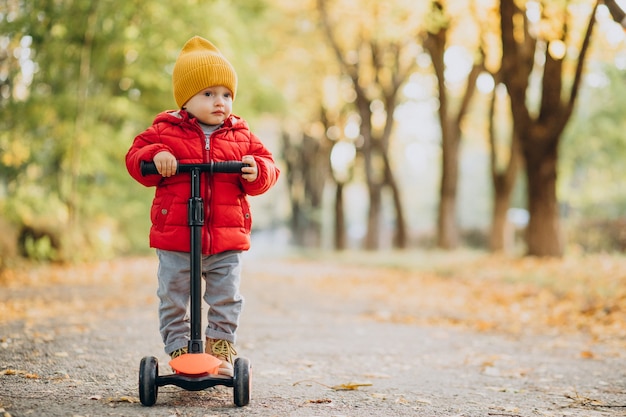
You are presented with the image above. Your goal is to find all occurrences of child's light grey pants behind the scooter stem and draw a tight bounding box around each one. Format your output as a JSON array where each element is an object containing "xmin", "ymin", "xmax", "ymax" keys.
[{"xmin": 157, "ymin": 249, "xmax": 244, "ymax": 355}]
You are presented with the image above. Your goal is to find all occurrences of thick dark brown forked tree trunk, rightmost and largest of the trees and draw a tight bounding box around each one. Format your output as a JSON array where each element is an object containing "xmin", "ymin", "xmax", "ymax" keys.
[{"xmin": 500, "ymin": 0, "xmax": 599, "ymax": 256}]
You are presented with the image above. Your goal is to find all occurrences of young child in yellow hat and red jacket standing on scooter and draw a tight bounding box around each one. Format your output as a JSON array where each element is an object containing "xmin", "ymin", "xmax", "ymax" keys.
[{"xmin": 126, "ymin": 36, "xmax": 279, "ymax": 376}]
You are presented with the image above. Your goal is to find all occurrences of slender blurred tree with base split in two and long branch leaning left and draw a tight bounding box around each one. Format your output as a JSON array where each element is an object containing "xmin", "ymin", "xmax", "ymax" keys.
[{"xmin": 317, "ymin": 0, "xmax": 416, "ymax": 250}]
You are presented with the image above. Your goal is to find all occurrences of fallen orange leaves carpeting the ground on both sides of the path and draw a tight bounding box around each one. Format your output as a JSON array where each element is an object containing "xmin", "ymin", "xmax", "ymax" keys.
[{"xmin": 0, "ymin": 251, "xmax": 626, "ymax": 355}]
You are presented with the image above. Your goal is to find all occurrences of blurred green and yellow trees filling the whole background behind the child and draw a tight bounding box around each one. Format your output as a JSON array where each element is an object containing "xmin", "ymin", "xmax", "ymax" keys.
[{"xmin": 0, "ymin": 0, "xmax": 626, "ymax": 261}]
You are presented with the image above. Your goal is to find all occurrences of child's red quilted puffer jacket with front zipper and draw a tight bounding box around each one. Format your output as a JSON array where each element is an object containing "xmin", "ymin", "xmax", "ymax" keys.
[{"xmin": 126, "ymin": 110, "xmax": 280, "ymax": 255}]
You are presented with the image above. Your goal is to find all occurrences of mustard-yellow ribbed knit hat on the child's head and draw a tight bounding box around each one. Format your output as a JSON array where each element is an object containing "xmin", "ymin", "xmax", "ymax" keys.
[{"xmin": 172, "ymin": 36, "xmax": 237, "ymax": 108}]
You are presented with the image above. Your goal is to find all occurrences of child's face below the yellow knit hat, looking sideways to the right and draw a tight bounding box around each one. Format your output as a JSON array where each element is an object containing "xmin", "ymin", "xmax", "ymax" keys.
[{"xmin": 183, "ymin": 85, "xmax": 233, "ymax": 125}]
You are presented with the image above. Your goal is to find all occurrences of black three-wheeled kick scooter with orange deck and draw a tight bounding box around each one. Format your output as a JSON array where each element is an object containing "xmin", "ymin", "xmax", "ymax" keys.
[{"xmin": 139, "ymin": 161, "xmax": 251, "ymax": 407}]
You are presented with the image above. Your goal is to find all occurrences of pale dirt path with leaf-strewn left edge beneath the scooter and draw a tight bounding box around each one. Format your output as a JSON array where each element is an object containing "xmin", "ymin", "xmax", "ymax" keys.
[{"xmin": 0, "ymin": 249, "xmax": 626, "ymax": 417}]
